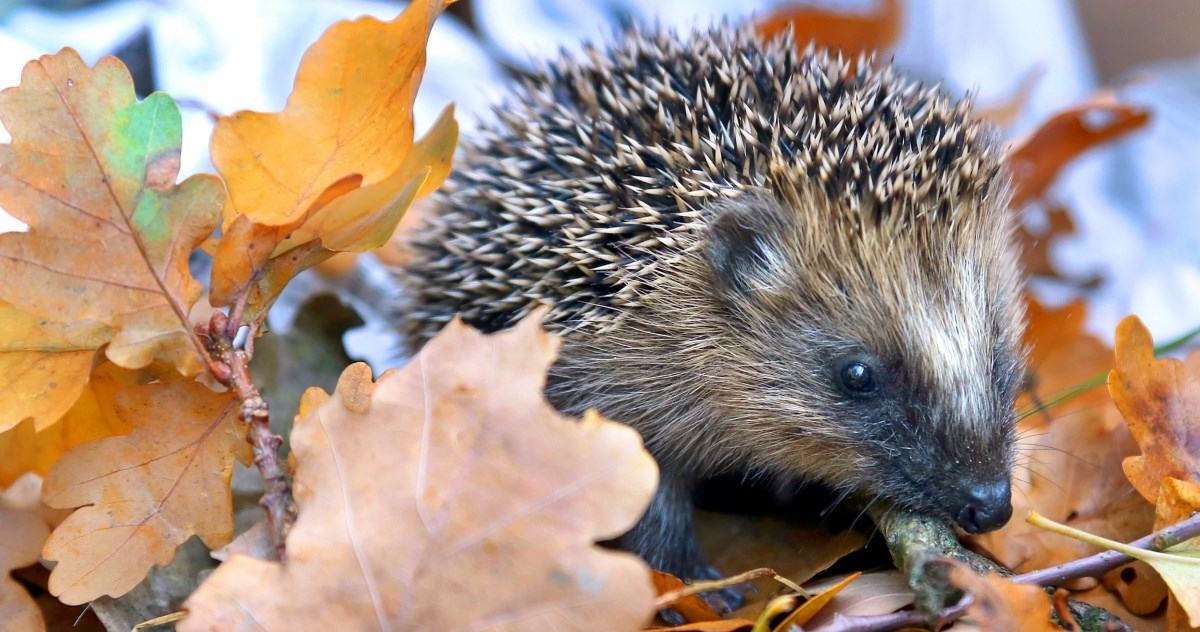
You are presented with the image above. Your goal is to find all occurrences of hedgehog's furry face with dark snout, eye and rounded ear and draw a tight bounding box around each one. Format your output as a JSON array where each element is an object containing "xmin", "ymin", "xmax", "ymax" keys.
[{"xmin": 706, "ymin": 195, "xmax": 1022, "ymax": 532}]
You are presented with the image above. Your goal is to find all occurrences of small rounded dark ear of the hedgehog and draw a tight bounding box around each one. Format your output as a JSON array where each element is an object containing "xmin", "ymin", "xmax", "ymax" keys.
[{"xmin": 704, "ymin": 204, "xmax": 786, "ymax": 299}]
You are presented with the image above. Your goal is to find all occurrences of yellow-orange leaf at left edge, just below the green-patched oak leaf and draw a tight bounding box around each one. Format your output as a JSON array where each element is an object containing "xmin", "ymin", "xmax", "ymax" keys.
[{"xmin": 0, "ymin": 301, "xmax": 108, "ymax": 436}]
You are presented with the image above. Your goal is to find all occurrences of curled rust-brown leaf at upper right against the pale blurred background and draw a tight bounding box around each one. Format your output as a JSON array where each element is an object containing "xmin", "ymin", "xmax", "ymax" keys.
[{"xmin": 1008, "ymin": 92, "xmax": 1150, "ymax": 209}]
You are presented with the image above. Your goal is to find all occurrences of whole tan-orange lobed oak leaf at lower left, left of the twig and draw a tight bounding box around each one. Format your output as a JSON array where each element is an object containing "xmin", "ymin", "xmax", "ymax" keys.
[{"xmin": 42, "ymin": 381, "xmax": 250, "ymax": 604}]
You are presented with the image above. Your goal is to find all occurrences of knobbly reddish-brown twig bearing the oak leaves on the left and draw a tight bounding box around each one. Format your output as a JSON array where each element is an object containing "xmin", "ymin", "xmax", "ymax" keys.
[{"xmin": 202, "ymin": 312, "xmax": 296, "ymax": 562}]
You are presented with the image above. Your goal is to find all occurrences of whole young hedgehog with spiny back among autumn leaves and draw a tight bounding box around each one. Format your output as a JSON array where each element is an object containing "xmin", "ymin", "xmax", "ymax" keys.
[{"xmin": 398, "ymin": 24, "xmax": 1025, "ymax": 602}]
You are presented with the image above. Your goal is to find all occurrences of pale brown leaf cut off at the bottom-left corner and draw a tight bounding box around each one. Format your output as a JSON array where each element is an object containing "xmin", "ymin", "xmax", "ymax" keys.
[{"xmin": 0, "ymin": 480, "xmax": 50, "ymax": 632}]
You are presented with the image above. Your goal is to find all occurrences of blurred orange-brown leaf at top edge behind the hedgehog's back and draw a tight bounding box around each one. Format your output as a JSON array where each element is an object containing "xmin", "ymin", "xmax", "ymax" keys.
[{"xmin": 755, "ymin": 0, "xmax": 902, "ymax": 60}]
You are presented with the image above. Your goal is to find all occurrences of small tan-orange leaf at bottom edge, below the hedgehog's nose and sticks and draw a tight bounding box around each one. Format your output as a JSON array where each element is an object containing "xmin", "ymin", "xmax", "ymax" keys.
[{"xmin": 950, "ymin": 562, "xmax": 1062, "ymax": 632}]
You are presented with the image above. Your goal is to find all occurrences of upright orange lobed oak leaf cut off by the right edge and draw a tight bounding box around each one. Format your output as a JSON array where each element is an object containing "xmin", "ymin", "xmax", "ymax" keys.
[{"xmin": 1109, "ymin": 315, "xmax": 1200, "ymax": 504}]
